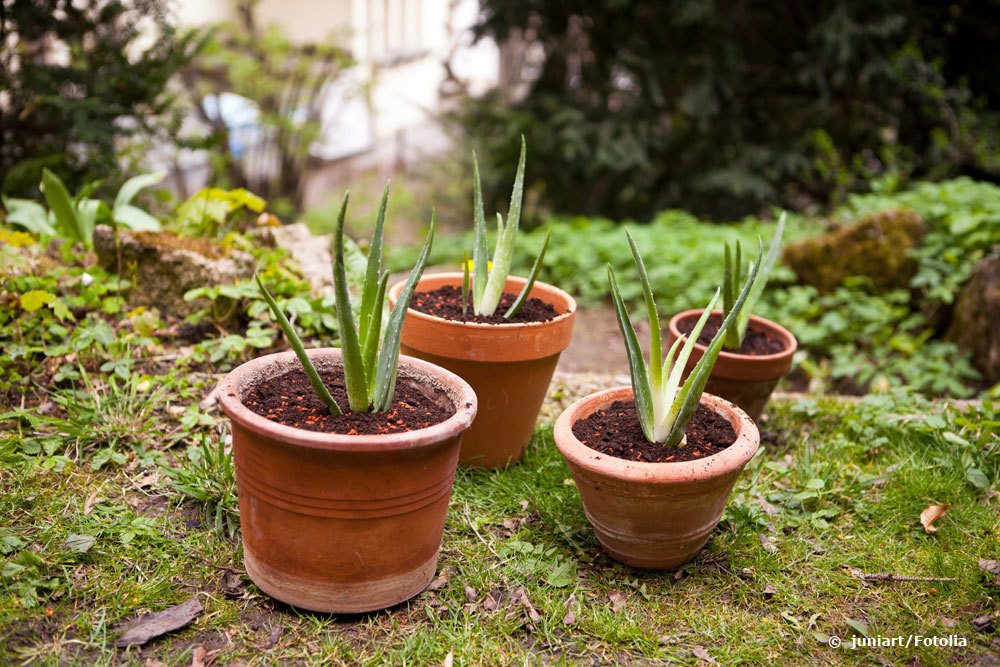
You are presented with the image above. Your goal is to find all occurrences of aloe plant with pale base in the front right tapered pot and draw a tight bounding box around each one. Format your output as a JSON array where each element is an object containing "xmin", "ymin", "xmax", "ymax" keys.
[{"xmin": 608, "ymin": 230, "xmax": 763, "ymax": 447}]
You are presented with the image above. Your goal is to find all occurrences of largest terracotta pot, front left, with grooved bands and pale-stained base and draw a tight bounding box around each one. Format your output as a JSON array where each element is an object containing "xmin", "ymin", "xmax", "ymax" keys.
[{"xmin": 219, "ymin": 348, "xmax": 476, "ymax": 613}]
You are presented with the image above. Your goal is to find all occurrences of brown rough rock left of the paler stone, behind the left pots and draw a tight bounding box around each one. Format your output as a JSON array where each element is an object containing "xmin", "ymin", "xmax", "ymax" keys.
[{"xmin": 94, "ymin": 225, "xmax": 253, "ymax": 317}]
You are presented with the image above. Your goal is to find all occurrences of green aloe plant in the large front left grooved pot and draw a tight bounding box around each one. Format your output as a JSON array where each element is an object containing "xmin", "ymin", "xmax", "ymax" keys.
[{"xmin": 255, "ymin": 185, "xmax": 436, "ymax": 416}]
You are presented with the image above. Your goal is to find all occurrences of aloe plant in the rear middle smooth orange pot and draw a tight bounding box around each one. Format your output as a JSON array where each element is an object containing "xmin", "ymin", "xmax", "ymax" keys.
[{"xmin": 463, "ymin": 136, "xmax": 549, "ymax": 319}]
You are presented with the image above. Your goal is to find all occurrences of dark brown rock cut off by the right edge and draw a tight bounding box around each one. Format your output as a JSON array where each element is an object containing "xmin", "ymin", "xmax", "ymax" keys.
[{"xmin": 945, "ymin": 253, "xmax": 1000, "ymax": 384}]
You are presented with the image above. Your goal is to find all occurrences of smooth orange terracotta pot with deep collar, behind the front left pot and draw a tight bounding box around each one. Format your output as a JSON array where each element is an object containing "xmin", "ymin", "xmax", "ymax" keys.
[{"xmin": 389, "ymin": 273, "xmax": 576, "ymax": 468}]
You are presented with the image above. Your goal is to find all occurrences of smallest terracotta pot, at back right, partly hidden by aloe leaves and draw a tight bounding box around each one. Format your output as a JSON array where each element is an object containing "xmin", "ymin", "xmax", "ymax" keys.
[{"xmin": 667, "ymin": 310, "xmax": 798, "ymax": 421}]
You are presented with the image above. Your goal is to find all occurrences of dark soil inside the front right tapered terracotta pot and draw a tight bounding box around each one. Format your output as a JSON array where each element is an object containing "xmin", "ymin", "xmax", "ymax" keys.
[{"xmin": 573, "ymin": 400, "xmax": 736, "ymax": 463}]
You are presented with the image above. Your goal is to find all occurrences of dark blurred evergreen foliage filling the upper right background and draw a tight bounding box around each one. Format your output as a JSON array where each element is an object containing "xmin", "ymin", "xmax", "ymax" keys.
[{"xmin": 455, "ymin": 0, "xmax": 1000, "ymax": 220}]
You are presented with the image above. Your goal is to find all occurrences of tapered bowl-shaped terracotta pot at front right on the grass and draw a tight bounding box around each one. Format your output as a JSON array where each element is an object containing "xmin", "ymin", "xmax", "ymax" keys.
[{"xmin": 555, "ymin": 387, "xmax": 760, "ymax": 569}]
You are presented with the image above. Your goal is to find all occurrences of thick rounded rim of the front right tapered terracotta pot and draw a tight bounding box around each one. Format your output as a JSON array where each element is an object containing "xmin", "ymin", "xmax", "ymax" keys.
[{"xmin": 553, "ymin": 386, "xmax": 760, "ymax": 484}]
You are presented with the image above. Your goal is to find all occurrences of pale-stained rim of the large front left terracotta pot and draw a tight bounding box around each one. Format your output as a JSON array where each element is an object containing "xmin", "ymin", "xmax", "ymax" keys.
[{"xmin": 219, "ymin": 347, "xmax": 478, "ymax": 452}]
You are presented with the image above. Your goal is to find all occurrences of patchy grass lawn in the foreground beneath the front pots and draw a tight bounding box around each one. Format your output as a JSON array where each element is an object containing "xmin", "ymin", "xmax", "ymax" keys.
[{"xmin": 0, "ymin": 382, "xmax": 1000, "ymax": 665}]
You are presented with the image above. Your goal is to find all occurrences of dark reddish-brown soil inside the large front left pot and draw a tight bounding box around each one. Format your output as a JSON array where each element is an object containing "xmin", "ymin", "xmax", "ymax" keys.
[{"xmin": 243, "ymin": 368, "xmax": 455, "ymax": 435}]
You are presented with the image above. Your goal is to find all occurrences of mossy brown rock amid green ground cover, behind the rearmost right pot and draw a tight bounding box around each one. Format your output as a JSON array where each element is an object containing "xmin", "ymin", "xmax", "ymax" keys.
[{"xmin": 784, "ymin": 210, "xmax": 926, "ymax": 292}]
